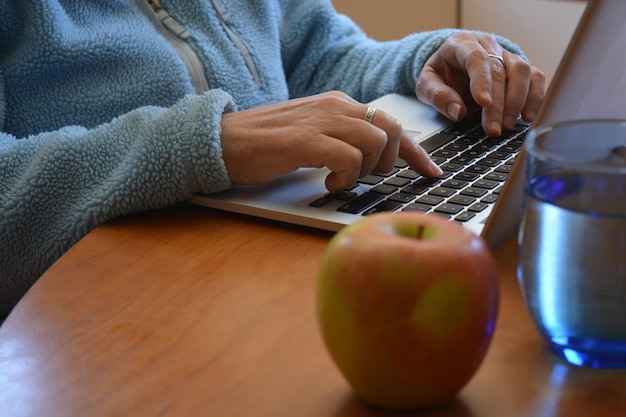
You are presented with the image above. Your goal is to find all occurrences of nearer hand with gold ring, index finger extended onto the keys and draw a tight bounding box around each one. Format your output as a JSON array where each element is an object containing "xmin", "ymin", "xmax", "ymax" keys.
[{"xmin": 221, "ymin": 92, "xmax": 441, "ymax": 190}]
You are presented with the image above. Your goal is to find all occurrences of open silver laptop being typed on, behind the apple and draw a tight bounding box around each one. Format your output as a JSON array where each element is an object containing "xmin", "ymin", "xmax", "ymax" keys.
[{"xmin": 190, "ymin": 0, "xmax": 626, "ymax": 248}]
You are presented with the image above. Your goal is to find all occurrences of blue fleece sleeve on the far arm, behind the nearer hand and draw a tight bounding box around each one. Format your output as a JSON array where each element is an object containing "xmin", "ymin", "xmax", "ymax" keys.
[{"xmin": 281, "ymin": 1, "xmax": 523, "ymax": 102}]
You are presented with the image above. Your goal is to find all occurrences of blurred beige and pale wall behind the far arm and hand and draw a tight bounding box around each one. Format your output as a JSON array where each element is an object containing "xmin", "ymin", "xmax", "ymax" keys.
[{"xmin": 332, "ymin": 0, "xmax": 584, "ymax": 78}]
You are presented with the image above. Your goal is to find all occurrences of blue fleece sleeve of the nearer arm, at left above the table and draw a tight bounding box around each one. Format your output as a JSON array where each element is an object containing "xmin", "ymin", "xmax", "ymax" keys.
[{"xmin": 0, "ymin": 90, "xmax": 233, "ymax": 317}]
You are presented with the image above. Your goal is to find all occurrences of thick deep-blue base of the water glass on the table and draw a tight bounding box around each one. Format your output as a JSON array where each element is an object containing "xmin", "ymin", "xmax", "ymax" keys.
[{"xmin": 548, "ymin": 337, "xmax": 626, "ymax": 369}]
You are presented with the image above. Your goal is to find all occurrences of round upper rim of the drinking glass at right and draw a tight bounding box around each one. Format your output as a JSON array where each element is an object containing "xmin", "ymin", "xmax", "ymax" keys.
[{"xmin": 524, "ymin": 119, "xmax": 626, "ymax": 174}]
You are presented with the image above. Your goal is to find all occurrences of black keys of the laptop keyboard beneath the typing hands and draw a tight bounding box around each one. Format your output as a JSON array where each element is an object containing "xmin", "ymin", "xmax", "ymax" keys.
[{"xmin": 310, "ymin": 114, "xmax": 530, "ymax": 222}]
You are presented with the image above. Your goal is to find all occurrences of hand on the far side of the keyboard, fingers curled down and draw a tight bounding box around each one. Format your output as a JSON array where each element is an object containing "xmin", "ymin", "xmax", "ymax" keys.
[{"xmin": 416, "ymin": 32, "xmax": 545, "ymax": 136}]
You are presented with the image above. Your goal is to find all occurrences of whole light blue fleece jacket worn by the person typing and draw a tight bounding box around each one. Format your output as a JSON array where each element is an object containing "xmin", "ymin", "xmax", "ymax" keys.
[{"xmin": 0, "ymin": 0, "xmax": 519, "ymax": 317}]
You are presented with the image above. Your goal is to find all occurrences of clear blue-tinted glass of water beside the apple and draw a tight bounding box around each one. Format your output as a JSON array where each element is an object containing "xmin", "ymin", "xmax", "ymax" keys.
[{"xmin": 518, "ymin": 120, "xmax": 626, "ymax": 368}]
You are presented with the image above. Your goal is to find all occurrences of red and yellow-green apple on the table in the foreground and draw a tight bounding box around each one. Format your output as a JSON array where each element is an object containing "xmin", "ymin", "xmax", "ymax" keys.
[{"xmin": 316, "ymin": 212, "xmax": 499, "ymax": 410}]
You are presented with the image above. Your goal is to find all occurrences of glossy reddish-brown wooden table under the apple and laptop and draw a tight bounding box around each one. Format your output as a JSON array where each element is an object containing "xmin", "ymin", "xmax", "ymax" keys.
[{"xmin": 0, "ymin": 205, "xmax": 626, "ymax": 417}]
